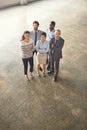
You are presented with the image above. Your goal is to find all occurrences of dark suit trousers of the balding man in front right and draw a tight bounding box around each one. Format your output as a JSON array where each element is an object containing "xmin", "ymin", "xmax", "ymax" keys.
[{"xmin": 52, "ymin": 57, "xmax": 60, "ymax": 80}]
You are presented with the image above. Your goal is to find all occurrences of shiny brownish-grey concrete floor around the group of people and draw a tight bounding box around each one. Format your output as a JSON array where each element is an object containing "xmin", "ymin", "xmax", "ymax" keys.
[{"xmin": 0, "ymin": 0, "xmax": 87, "ymax": 130}]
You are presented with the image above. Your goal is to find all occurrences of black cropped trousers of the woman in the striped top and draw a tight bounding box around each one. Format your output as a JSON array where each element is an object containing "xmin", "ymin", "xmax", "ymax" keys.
[{"xmin": 22, "ymin": 57, "xmax": 33, "ymax": 75}]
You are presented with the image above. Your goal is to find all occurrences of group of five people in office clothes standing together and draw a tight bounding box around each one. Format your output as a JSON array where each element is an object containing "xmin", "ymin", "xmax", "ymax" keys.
[{"xmin": 21, "ymin": 21, "xmax": 64, "ymax": 82}]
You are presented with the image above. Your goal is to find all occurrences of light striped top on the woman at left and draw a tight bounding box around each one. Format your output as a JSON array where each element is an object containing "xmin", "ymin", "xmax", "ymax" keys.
[{"xmin": 21, "ymin": 40, "xmax": 35, "ymax": 59}]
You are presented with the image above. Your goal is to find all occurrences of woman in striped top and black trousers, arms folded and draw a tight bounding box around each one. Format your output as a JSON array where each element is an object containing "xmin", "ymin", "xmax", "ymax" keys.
[{"xmin": 21, "ymin": 31, "xmax": 34, "ymax": 80}]
